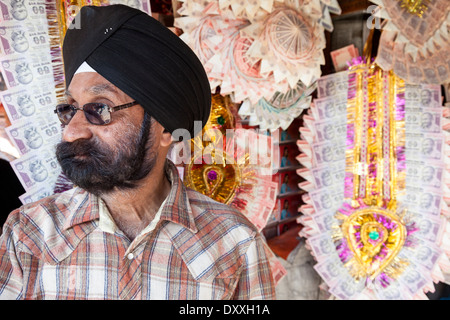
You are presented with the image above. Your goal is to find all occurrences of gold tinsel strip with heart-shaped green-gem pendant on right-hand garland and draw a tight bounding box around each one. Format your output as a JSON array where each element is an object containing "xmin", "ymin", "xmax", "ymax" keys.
[{"xmin": 340, "ymin": 63, "xmax": 408, "ymax": 280}]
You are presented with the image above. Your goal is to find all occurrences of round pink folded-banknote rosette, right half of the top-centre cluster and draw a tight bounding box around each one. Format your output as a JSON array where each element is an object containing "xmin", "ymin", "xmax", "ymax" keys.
[{"xmin": 241, "ymin": 1, "xmax": 325, "ymax": 88}]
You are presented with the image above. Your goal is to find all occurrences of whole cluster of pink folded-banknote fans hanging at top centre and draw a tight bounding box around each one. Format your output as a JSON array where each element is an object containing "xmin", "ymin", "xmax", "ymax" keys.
[{"xmin": 174, "ymin": 0, "xmax": 340, "ymax": 130}]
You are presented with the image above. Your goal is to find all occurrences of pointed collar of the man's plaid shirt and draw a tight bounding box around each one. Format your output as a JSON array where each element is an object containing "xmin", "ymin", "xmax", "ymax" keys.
[{"xmin": 63, "ymin": 159, "xmax": 198, "ymax": 233}]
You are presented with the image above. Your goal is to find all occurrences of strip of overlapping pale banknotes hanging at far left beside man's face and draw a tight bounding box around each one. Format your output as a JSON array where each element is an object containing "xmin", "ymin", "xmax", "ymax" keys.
[{"xmin": 0, "ymin": 0, "xmax": 63, "ymax": 203}]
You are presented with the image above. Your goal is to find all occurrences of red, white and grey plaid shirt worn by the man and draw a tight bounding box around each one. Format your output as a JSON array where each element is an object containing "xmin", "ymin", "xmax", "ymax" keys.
[{"xmin": 0, "ymin": 163, "xmax": 275, "ymax": 300}]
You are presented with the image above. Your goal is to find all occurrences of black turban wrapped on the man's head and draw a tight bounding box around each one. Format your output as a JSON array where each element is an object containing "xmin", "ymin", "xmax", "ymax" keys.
[{"xmin": 63, "ymin": 5, "xmax": 211, "ymax": 137}]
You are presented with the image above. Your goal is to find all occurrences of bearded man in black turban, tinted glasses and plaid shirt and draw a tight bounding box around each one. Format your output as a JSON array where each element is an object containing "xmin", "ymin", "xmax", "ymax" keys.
[{"xmin": 0, "ymin": 5, "xmax": 274, "ymax": 299}]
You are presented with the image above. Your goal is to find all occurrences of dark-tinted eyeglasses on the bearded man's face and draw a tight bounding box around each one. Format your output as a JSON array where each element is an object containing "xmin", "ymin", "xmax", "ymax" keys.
[{"xmin": 54, "ymin": 101, "xmax": 138, "ymax": 125}]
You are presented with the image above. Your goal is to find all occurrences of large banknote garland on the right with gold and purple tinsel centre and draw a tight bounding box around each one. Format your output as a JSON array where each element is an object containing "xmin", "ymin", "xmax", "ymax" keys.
[{"xmin": 297, "ymin": 61, "xmax": 450, "ymax": 299}]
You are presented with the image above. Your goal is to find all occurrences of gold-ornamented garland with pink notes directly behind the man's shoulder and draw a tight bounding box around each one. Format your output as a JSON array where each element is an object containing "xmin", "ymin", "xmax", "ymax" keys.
[{"xmin": 182, "ymin": 94, "xmax": 278, "ymax": 230}]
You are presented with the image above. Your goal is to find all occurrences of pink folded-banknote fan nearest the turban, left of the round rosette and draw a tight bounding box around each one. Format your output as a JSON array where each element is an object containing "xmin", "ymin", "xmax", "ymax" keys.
[{"xmin": 174, "ymin": 0, "xmax": 288, "ymax": 103}]
